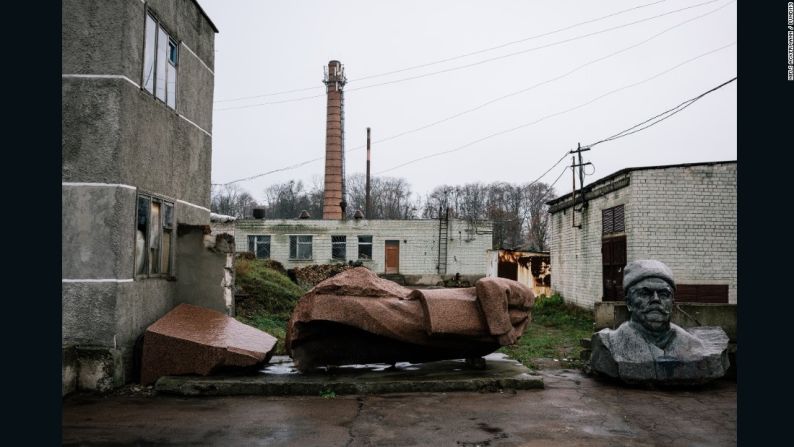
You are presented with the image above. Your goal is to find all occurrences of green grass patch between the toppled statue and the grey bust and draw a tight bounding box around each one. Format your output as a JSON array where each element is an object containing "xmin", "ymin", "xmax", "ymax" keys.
[{"xmin": 500, "ymin": 295, "xmax": 593, "ymax": 369}]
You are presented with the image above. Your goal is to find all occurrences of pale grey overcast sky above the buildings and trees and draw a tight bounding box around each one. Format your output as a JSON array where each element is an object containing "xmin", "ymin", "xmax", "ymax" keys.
[{"xmin": 199, "ymin": 0, "xmax": 738, "ymax": 203}]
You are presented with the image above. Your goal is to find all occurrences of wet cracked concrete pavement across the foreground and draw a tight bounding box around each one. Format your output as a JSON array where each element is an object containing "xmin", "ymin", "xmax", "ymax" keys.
[{"xmin": 63, "ymin": 370, "xmax": 737, "ymax": 447}]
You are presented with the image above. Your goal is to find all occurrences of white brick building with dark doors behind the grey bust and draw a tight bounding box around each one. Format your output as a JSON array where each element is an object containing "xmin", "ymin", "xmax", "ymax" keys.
[{"xmin": 548, "ymin": 161, "xmax": 737, "ymax": 308}]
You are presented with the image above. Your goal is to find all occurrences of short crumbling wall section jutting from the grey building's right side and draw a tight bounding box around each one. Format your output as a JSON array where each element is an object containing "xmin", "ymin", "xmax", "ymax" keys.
[{"xmin": 174, "ymin": 226, "xmax": 234, "ymax": 315}]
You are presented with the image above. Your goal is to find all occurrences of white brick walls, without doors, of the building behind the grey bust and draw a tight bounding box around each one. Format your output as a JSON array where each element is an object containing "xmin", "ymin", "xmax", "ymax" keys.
[{"xmin": 551, "ymin": 163, "xmax": 737, "ymax": 308}]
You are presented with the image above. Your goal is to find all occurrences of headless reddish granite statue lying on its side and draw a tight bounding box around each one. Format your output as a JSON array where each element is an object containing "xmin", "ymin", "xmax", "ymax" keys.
[{"xmin": 286, "ymin": 267, "xmax": 535, "ymax": 371}]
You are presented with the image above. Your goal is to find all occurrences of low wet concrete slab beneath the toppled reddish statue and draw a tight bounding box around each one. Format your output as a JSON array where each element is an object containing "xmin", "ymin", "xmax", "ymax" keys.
[{"xmin": 155, "ymin": 353, "xmax": 543, "ymax": 396}]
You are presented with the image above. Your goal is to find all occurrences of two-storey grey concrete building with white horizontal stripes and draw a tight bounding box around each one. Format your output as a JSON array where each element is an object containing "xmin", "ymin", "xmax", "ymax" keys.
[{"xmin": 61, "ymin": 0, "xmax": 220, "ymax": 393}]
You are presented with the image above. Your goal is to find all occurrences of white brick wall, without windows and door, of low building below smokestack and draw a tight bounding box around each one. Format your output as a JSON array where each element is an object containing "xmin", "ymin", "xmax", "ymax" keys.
[{"xmin": 230, "ymin": 219, "xmax": 492, "ymax": 278}]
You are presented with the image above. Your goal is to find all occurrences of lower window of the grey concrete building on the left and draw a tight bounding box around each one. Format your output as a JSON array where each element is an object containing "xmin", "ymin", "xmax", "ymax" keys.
[{"xmin": 135, "ymin": 195, "xmax": 174, "ymax": 276}]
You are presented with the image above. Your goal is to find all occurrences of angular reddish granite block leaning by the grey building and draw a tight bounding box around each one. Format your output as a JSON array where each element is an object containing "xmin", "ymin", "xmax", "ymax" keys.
[{"xmin": 141, "ymin": 304, "xmax": 276, "ymax": 385}]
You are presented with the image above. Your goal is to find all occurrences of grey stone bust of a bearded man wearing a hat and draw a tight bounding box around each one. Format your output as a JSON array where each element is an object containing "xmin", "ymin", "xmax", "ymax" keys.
[{"xmin": 590, "ymin": 260, "xmax": 729, "ymax": 385}]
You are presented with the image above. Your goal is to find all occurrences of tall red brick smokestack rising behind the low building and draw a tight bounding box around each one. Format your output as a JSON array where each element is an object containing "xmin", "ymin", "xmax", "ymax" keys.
[{"xmin": 323, "ymin": 61, "xmax": 347, "ymax": 220}]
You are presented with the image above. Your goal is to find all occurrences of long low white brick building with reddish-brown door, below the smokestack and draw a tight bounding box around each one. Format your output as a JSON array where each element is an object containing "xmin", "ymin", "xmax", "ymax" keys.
[{"xmin": 226, "ymin": 219, "xmax": 493, "ymax": 284}]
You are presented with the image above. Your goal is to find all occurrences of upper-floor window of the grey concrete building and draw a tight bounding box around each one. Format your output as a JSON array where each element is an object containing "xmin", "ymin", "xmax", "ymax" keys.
[{"xmin": 142, "ymin": 14, "xmax": 179, "ymax": 109}]
